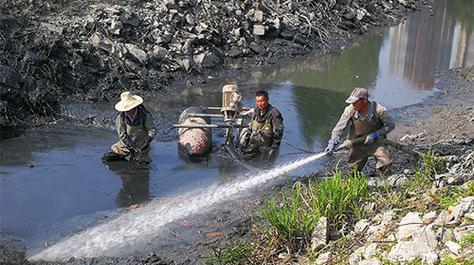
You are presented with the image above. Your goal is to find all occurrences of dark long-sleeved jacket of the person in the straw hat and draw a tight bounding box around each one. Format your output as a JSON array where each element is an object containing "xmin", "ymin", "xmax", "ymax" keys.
[{"xmin": 115, "ymin": 105, "xmax": 157, "ymax": 149}]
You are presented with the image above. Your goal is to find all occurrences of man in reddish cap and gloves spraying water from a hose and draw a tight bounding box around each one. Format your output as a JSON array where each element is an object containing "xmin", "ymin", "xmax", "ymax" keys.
[{"xmin": 325, "ymin": 87, "xmax": 395, "ymax": 177}]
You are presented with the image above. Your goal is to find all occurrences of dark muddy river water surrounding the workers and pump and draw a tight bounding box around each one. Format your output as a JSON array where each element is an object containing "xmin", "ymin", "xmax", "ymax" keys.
[{"xmin": 0, "ymin": 0, "xmax": 474, "ymax": 254}]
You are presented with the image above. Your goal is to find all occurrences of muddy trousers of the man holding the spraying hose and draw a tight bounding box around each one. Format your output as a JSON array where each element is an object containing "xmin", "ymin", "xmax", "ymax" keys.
[{"xmin": 348, "ymin": 144, "xmax": 392, "ymax": 177}]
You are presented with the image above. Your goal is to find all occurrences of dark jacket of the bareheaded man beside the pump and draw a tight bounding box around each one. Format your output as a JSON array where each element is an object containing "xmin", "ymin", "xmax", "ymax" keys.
[{"xmin": 250, "ymin": 104, "xmax": 284, "ymax": 149}]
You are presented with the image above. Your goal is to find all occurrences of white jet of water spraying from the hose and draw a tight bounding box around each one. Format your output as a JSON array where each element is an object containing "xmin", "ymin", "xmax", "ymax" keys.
[{"xmin": 30, "ymin": 153, "xmax": 326, "ymax": 261}]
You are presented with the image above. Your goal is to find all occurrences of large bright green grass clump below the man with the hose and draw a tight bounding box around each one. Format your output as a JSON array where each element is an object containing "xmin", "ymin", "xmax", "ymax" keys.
[{"xmin": 261, "ymin": 171, "xmax": 368, "ymax": 251}]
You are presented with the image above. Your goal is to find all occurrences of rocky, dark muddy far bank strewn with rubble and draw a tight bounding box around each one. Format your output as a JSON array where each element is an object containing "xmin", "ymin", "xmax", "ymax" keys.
[{"xmin": 0, "ymin": 0, "xmax": 425, "ymax": 139}]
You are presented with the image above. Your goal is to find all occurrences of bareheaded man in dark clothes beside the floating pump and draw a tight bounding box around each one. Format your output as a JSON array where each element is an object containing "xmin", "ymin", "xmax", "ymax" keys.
[{"xmin": 240, "ymin": 90, "xmax": 284, "ymax": 167}]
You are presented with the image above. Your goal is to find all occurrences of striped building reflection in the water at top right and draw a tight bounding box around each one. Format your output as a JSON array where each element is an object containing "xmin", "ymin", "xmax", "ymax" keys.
[{"xmin": 387, "ymin": 0, "xmax": 474, "ymax": 89}]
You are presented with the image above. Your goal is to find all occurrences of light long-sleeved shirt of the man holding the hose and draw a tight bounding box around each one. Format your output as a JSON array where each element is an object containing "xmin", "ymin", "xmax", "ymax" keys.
[{"xmin": 331, "ymin": 101, "xmax": 395, "ymax": 142}]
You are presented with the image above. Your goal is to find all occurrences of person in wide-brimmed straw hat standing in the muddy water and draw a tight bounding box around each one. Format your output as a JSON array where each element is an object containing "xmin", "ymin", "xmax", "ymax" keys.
[{"xmin": 102, "ymin": 91, "xmax": 156, "ymax": 164}]
